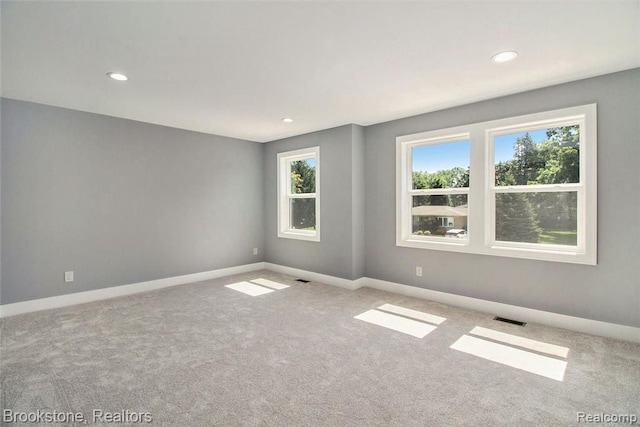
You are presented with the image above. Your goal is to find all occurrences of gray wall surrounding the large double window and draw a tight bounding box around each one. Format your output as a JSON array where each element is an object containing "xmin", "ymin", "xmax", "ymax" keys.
[{"xmin": 365, "ymin": 69, "xmax": 640, "ymax": 326}]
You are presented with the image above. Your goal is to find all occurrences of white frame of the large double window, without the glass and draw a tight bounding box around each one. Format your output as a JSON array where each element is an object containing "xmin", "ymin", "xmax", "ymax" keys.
[{"xmin": 396, "ymin": 104, "xmax": 597, "ymax": 265}]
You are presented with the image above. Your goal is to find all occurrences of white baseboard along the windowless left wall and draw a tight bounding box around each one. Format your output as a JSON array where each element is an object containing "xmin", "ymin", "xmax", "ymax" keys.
[{"xmin": 0, "ymin": 262, "xmax": 265, "ymax": 318}]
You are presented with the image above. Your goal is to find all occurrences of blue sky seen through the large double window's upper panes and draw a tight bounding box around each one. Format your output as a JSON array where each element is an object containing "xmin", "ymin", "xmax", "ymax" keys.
[{"xmin": 412, "ymin": 129, "xmax": 547, "ymax": 173}]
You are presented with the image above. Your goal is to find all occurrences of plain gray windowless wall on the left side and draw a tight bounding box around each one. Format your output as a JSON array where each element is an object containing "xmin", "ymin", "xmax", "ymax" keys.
[{"xmin": 1, "ymin": 99, "xmax": 264, "ymax": 304}]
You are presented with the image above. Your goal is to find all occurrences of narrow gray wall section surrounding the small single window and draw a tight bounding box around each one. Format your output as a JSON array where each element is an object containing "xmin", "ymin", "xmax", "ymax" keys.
[{"xmin": 264, "ymin": 125, "xmax": 364, "ymax": 279}]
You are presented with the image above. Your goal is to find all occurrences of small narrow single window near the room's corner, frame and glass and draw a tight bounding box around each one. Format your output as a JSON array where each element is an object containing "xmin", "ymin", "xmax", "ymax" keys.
[{"xmin": 278, "ymin": 147, "xmax": 320, "ymax": 241}]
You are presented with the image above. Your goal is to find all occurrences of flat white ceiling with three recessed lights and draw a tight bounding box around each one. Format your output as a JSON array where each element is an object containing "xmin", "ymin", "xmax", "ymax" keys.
[{"xmin": 1, "ymin": 0, "xmax": 640, "ymax": 142}]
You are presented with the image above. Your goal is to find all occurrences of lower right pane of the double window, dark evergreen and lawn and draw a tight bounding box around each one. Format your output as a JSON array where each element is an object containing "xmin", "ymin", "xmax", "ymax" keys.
[{"xmin": 496, "ymin": 191, "xmax": 578, "ymax": 246}]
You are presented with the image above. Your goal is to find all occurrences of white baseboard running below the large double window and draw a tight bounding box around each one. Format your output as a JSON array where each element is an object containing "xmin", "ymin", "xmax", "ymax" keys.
[{"xmin": 364, "ymin": 278, "xmax": 640, "ymax": 343}]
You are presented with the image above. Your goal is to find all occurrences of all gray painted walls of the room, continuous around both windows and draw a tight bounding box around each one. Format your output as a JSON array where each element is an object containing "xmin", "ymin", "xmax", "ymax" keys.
[{"xmin": 0, "ymin": 69, "xmax": 640, "ymax": 327}]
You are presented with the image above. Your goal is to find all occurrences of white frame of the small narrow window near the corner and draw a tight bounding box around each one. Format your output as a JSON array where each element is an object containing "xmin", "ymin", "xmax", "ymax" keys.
[{"xmin": 277, "ymin": 147, "xmax": 320, "ymax": 242}]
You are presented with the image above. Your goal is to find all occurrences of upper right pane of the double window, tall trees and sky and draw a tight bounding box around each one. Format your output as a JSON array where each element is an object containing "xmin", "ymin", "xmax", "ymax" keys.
[{"xmin": 493, "ymin": 125, "xmax": 580, "ymax": 186}]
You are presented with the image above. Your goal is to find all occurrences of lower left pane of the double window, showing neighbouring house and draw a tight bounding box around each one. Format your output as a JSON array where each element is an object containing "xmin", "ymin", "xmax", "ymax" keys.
[{"xmin": 411, "ymin": 194, "xmax": 468, "ymax": 238}]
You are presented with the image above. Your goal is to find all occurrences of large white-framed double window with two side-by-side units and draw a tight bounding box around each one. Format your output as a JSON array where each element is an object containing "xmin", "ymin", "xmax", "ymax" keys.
[{"xmin": 396, "ymin": 105, "xmax": 597, "ymax": 264}]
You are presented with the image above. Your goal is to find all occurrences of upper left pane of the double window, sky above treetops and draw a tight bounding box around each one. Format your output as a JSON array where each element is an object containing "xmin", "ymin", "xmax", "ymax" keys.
[{"xmin": 411, "ymin": 140, "xmax": 470, "ymax": 190}]
